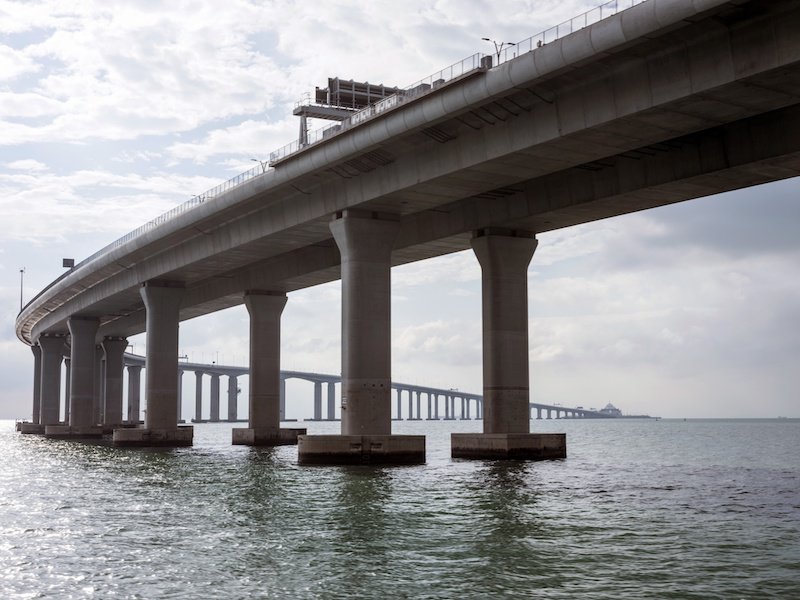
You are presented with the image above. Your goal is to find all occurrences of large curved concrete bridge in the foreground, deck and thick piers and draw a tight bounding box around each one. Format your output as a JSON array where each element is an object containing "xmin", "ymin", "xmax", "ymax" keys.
[{"xmin": 16, "ymin": 0, "xmax": 800, "ymax": 463}]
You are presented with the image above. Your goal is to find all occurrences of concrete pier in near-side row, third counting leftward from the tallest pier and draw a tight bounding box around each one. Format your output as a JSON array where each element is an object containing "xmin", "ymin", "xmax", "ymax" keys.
[{"xmin": 45, "ymin": 316, "xmax": 103, "ymax": 438}]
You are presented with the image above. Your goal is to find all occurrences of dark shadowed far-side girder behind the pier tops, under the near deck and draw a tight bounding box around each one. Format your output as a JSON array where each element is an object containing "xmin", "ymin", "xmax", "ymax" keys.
[{"xmin": 79, "ymin": 105, "xmax": 800, "ymax": 335}]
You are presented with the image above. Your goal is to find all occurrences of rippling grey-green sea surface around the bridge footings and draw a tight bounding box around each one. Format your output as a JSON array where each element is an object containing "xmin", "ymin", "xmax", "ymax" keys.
[{"xmin": 0, "ymin": 419, "xmax": 800, "ymax": 599}]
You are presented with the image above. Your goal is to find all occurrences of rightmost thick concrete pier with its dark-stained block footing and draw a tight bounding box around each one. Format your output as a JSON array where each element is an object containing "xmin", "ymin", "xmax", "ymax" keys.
[{"xmin": 451, "ymin": 230, "xmax": 566, "ymax": 459}]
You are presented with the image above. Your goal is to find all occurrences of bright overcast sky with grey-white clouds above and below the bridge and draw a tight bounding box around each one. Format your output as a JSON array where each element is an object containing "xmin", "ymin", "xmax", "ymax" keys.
[{"xmin": 0, "ymin": 0, "xmax": 800, "ymax": 418}]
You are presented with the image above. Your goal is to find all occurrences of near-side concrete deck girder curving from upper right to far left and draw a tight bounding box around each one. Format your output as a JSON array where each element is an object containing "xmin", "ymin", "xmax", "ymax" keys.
[{"xmin": 18, "ymin": 0, "xmax": 800, "ymax": 341}]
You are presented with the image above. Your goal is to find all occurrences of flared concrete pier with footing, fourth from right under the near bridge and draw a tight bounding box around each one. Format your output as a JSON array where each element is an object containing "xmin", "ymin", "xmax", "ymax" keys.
[{"xmin": 114, "ymin": 281, "xmax": 194, "ymax": 446}]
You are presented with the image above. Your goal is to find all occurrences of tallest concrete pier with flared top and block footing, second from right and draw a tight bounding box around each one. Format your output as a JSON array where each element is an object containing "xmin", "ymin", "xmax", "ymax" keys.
[{"xmin": 298, "ymin": 211, "xmax": 425, "ymax": 464}]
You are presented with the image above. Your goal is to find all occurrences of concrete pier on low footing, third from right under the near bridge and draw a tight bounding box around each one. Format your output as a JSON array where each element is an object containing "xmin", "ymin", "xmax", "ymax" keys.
[{"xmin": 233, "ymin": 291, "xmax": 306, "ymax": 446}]
